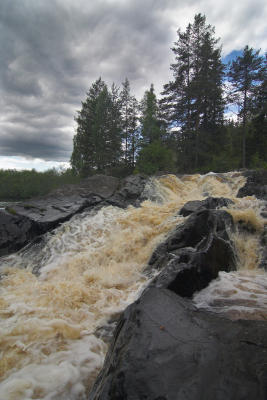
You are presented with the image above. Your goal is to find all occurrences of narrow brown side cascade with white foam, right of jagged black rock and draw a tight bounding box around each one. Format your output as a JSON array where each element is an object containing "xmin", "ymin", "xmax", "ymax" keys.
[{"xmin": 194, "ymin": 192, "xmax": 267, "ymax": 320}]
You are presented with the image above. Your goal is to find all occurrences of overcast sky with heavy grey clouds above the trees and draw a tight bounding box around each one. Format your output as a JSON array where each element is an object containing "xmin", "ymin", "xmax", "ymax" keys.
[{"xmin": 0, "ymin": 0, "xmax": 267, "ymax": 170}]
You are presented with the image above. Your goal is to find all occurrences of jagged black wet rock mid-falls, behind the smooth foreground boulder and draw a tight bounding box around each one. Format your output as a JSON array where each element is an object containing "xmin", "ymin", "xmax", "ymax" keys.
[{"xmin": 147, "ymin": 210, "xmax": 238, "ymax": 297}]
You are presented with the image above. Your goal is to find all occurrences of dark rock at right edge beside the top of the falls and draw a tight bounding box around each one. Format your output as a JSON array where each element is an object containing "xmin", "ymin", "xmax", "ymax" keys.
[{"xmin": 237, "ymin": 170, "xmax": 267, "ymax": 200}]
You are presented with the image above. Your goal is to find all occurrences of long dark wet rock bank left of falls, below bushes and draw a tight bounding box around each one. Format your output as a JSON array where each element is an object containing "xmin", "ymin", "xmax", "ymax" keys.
[{"xmin": 0, "ymin": 175, "xmax": 146, "ymax": 256}]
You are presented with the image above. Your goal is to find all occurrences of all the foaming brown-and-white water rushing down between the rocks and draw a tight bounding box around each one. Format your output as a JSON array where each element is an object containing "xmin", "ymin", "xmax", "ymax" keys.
[{"xmin": 0, "ymin": 173, "xmax": 266, "ymax": 400}]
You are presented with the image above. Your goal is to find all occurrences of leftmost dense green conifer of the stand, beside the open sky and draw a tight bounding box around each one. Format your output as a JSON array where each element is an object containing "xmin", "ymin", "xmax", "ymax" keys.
[{"xmin": 71, "ymin": 78, "xmax": 121, "ymax": 175}]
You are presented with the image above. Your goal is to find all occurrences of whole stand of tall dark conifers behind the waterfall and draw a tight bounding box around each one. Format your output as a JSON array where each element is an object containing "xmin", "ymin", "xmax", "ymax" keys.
[{"xmin": 71, "ymin": 14, "xmax": 267, "ymax": 176}]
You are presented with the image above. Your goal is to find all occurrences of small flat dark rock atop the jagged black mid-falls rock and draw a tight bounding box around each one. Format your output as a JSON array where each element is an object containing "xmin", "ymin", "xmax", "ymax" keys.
[{"xmin": 179, "ymin": 197, "xmax": 234, "ymax": 217}]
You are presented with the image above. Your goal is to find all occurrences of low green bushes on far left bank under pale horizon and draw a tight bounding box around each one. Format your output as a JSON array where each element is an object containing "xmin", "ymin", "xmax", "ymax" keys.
[{"xmin": 0, "ymin": 169, "xmax": 80, "ymax": 201}]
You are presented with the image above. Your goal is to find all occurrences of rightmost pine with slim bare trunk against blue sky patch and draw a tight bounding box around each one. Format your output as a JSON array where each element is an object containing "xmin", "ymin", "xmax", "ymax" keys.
[{"xmin": 228, "ymin": 46, "xmax": 263, "ymax": 168}]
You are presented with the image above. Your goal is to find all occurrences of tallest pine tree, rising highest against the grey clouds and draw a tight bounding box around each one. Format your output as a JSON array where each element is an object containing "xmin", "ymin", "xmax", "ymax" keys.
[{"xmin": 161, "ymin": 14, "xmax": 224, "ymax": 168}]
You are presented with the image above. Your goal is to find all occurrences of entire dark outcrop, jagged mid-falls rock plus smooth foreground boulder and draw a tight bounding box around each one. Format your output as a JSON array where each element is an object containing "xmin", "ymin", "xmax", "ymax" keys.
[{"xmin": 88, "ymin": 198, "xmax": 267, "ymax": 400}]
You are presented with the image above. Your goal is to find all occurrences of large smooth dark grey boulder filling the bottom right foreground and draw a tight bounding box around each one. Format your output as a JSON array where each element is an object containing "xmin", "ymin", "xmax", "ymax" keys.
[{"xmin": 89, "ymin": 288, "xmax": 267, "ymax": 400}]
